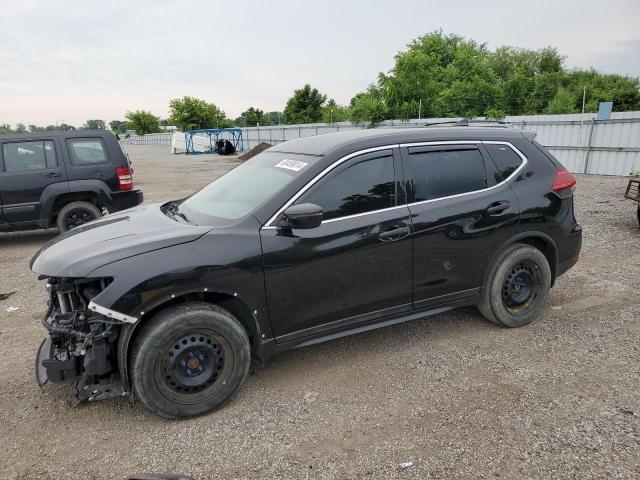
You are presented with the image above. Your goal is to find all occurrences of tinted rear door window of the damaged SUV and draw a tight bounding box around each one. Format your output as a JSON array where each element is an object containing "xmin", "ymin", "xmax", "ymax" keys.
[{"xmin": 408, "ymin": 149, "xmax": 487, "ymax": 202}]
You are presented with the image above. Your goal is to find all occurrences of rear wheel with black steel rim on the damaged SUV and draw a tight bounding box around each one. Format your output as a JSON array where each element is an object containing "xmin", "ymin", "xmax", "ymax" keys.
[{"xmin": 478, "ymin": 243, "xmax": 551, "ymax": 328}]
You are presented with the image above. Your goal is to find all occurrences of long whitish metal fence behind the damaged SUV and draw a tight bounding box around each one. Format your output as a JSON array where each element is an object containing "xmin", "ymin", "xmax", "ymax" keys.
[{"xmin": 123, "ymin": 112, "xmax": 640, "ymax": 175}]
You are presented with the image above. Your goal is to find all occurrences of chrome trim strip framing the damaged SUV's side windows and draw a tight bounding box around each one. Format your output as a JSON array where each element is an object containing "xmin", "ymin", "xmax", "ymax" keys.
[{"xmin": 262, "ymin": 140, "xmax": 528, "ymax": 230}]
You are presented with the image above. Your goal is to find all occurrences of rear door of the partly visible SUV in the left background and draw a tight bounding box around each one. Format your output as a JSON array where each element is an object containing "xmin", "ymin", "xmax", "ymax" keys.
[{"xmin": 0, "ymin": 138, "xmax": 67, "ymax": 223}]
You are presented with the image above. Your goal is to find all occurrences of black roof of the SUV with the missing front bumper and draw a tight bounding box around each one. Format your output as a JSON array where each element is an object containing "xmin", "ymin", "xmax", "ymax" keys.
[{"xmin": 269, "ymin": 126, "xmax": 523, "ymax": 155}]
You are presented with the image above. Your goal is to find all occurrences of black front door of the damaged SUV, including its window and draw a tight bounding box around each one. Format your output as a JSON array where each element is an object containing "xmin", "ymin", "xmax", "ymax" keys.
[{"xmin": 261, "ymin": 149, "xmax": 412, "ymax": 342}]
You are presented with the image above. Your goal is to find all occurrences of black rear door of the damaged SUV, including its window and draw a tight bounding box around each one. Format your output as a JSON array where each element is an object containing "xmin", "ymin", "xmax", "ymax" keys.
[{"xmin": 401, "ymin": 142, "xmax": 520, "ymax": 308}]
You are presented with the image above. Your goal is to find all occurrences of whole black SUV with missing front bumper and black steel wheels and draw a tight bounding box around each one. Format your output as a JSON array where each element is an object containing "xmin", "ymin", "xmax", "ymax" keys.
[{"xmin": 31, "ymin": 126, "xmax": 582, "ymax": 418}]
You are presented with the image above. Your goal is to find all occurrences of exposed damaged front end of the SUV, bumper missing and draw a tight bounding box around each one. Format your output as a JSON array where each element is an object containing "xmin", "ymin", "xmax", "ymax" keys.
[{"xmin": 36, "ymin": 277, "xmax": 136, "ymax": 405}]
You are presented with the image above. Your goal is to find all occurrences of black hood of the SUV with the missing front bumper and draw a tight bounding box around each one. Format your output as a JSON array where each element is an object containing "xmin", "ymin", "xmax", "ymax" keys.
[{"xmin": 31, "ymin": 203, "xmax": 212, "ymax": 278}]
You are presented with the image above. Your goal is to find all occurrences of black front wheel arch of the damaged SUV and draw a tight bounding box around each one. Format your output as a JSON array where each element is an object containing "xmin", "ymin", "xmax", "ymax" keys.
[{"xmin": 117, "ymin": 290, "xmax": 264, "ymax": 392}]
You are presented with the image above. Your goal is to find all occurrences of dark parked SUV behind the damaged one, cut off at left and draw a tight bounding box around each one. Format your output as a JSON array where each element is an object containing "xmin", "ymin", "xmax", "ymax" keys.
[{"xmin": 0, "ymin": 130, "xmax": 142, "ymax": 232}]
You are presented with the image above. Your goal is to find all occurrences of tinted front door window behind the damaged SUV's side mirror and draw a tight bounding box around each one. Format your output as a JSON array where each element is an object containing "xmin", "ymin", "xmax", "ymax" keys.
[{"xmin": 296, "ymin": 154, "xmax": 395, "ymax": 220}]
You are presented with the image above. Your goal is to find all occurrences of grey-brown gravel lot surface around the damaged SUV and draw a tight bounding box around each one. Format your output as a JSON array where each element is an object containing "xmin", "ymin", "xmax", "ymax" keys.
[{"xmin": 0, "ymin": 146, "xmax": 640, "ymax": 479}]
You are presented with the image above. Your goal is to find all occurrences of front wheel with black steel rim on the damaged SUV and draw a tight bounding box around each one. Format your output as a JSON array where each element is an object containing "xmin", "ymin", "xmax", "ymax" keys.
[{"xmin": 130, "ymin": 302, "xmax": 251, "ymax": 418}]
